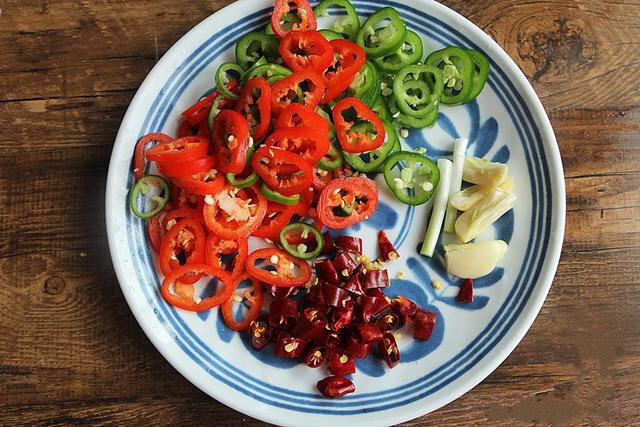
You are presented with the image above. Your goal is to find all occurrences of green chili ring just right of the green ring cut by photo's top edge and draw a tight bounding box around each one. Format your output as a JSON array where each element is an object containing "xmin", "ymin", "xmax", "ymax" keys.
[{"xmin": 356, "ymin": 7, "xmax": 407, "ymax": 58}]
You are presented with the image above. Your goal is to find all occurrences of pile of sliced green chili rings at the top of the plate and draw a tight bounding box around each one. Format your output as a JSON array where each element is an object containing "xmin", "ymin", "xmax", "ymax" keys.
[{"xmin": 209, "ymin": 0, "xmax": 490, "ymax": 205}]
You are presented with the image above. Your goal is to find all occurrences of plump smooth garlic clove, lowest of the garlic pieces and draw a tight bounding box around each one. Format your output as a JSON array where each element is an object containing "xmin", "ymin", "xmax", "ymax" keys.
[{"xmin": 444, "ymin": 240, "xmax": 509, "ymax": 279}]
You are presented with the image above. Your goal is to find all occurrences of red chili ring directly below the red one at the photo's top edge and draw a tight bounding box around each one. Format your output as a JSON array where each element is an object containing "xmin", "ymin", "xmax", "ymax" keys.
[{"xmin": 279, "ymin": 31, "xmax": 333, "ymax": 73}]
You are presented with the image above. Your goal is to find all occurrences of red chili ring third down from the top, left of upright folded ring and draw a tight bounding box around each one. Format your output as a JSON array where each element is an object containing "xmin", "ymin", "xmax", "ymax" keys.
[{"xmin": 271, "ymin": 70, "xmax": 326, "ymax": 116}]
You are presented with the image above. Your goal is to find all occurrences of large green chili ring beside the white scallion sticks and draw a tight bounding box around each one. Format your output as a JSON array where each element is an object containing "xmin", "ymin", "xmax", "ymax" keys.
[{"xmin": 383, "ymin": 151, "xmax": 440, "ymax": 206}]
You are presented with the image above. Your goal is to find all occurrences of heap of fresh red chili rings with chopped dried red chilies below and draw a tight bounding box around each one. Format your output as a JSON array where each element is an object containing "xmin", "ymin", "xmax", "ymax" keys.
[{"xmin": 130, "ymin": 0, "xmax": 444, "ymax": 397}]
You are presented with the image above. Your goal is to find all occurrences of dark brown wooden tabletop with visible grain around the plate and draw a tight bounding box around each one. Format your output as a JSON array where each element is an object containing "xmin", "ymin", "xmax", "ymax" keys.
[{"xmin": 0, "ymin": 0, "xmax": 640, "ymax": 425}]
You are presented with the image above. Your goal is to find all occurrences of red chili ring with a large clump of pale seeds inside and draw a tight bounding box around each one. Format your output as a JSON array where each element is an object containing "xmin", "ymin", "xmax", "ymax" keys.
[{"xmin": 203, "ymin": 185, "xmax": 267, "ymax": 239}]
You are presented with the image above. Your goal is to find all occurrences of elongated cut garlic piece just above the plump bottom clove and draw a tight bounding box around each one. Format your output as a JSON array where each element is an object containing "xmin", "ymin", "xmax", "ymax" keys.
[{"xmin": 456, "ymin": 188, "xmax": 516, "ymax": 243}]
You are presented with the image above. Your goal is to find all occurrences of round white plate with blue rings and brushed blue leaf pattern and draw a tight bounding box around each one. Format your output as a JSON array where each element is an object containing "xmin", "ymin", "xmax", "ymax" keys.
[{"xmin": 106, "ymin": 0, "xmax": 565, "ymax": 425}]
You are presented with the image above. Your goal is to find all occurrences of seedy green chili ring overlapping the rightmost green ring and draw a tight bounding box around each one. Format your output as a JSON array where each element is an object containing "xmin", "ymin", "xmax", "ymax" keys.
[{"xmin": 425, "ymin": 46, "xmax": 474, "ymax": 105}]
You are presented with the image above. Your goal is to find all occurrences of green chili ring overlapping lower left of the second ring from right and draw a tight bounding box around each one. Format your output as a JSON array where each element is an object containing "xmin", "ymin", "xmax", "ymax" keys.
[{"xmin": 393, "ymin": 65, "xmax": 443, "ymax": 118}]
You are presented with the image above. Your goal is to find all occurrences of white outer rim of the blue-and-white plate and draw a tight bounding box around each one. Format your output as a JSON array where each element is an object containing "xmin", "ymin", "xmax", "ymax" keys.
[{"xmin": 105, "ymin": 0, "xmax": 566, "ymax": 424}]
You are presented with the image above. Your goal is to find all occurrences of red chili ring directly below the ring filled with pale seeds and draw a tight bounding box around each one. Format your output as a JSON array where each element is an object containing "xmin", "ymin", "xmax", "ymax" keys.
[{"xmin": 205, "ymin": 233, "xmax": 249, "ymax": 280}]
